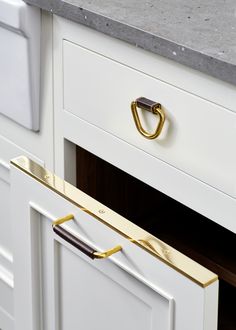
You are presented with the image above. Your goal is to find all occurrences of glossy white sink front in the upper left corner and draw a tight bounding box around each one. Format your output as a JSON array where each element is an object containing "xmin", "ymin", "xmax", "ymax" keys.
[{"xmin": 0, "ymin": 0, "xmax": 41, "ymax": 131}]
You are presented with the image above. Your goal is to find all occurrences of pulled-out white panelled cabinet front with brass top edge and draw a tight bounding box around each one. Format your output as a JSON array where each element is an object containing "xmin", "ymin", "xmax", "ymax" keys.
[{"xmin": 11, "ymin": 157, "xmax": 218, "ymax": 330}]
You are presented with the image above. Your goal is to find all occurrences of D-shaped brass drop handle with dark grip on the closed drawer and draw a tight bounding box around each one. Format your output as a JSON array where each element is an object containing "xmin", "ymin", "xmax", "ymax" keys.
[{"xmin": 131, "ymin": 97, "xmax": 165, "ymax": 140}]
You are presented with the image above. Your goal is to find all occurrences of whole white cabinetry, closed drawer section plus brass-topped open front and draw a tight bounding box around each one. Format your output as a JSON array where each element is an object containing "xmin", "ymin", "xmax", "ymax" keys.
[{"xmin": 0, "ymin": 8, "xmax": 236, "ymax": 330}]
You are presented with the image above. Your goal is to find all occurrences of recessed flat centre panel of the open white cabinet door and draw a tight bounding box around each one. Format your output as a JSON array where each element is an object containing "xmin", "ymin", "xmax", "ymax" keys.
[{"xmin": 59, "ymin": 245, "xmax": 173, "ymax": 330}]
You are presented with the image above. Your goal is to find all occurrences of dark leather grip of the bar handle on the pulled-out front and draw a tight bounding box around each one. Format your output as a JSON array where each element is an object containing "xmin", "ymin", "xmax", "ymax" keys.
[{"xmin": 53, "ymin": 226, "xmax": 96, "ymax": 259}]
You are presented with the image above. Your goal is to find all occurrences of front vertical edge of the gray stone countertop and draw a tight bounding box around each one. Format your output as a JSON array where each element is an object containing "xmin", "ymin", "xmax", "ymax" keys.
[{"xmin": 24, "ymin": 0, "xmax": 236, "ymax": 85}]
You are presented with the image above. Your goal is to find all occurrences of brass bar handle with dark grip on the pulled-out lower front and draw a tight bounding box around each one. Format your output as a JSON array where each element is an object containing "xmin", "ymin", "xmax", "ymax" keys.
[{"xmin": 52, "ymin": 214, "xmax": 122, "ymax": 259}]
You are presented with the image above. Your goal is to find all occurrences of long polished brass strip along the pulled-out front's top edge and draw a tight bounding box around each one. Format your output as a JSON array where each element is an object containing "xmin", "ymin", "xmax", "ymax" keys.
[{"xmin": 11, "ymin": 156, "xmax": 218, "ymax": 287}]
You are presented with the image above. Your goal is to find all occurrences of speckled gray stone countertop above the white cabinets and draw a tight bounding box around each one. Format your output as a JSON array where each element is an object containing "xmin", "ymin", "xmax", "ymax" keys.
[{"xmin": 25, "ymin": 0, "xmax": 236, "ymax": 85}]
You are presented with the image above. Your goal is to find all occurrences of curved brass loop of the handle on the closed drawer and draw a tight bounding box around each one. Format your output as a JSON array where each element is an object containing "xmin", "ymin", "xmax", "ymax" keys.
[{"xmin": 131, "ymin": 100, "xmax": 165, "ymax": 140}]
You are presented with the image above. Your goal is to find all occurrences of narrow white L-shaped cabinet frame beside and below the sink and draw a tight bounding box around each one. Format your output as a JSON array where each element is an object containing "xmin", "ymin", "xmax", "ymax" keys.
[{"xmin": 0, "ymin": 13, "xmax": 53, "ymax": 170}]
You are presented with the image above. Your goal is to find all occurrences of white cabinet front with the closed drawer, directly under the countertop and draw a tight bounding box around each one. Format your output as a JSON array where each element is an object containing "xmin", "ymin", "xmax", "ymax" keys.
[{"xmin": 53, "ymin": 16, "xmax": 236, "ymax": 233}]
